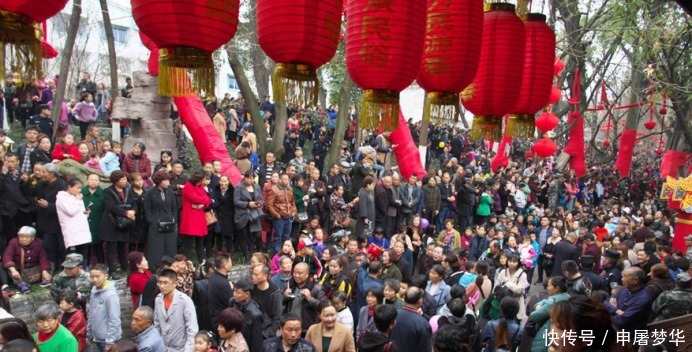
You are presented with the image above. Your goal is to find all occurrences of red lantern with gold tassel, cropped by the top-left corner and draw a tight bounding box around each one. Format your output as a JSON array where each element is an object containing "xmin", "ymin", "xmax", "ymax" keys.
[{"xmin": 0, "ymin": 0, "xmax": 67, "ymax": 80}]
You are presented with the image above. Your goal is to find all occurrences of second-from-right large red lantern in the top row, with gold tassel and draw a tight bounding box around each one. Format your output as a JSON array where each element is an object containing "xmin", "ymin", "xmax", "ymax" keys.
[{"xmin": 461, "ymin": 3, "xmax": 526, "ymax": 141}]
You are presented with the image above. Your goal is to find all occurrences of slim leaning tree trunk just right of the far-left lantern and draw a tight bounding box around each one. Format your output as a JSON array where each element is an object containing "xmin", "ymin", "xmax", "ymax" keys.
[{"xmin": 51, "ymin": 0, "xmax": 82, "ymax": 138}]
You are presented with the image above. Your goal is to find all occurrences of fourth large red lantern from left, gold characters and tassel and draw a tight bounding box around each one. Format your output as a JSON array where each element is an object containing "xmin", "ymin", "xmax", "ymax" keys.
[{"xmin": 346, "ymin": 0, "xmax": 427, "ymax": 129}]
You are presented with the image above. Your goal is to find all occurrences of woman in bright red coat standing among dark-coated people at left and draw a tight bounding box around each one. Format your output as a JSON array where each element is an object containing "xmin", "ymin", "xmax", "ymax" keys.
[{"xmin": 180, "ymin": 170, "xmax": 211, "ymax": 260}]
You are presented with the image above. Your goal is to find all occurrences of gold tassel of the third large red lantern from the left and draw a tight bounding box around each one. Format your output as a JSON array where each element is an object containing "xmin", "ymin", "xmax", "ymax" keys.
[{"xmin": 272, "ymin": 63, "xmax": 320, "ymax": 107}]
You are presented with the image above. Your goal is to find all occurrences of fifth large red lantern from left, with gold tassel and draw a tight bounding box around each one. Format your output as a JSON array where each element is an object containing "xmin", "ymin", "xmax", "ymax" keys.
[{"xmin": 416, "ymin": 0, "xmax": 483, "ymax": 122}]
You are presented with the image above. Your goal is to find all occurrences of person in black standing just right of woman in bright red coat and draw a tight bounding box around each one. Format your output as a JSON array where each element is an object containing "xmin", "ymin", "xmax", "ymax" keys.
[{"xmin": 212, "ymin": 176, "xmax": 236, "ymax": 253}]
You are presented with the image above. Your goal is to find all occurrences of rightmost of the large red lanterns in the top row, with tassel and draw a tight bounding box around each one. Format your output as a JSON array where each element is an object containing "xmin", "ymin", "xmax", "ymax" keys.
[{"xmin": 505, "ymin": 13, "xmax": 555, "ymax": 138}]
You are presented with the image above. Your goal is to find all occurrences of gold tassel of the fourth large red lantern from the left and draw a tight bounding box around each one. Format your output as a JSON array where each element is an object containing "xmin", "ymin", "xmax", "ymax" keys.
[{"xmin": 360, "ymin": 89, "xmax": 399, "ymax": 130}]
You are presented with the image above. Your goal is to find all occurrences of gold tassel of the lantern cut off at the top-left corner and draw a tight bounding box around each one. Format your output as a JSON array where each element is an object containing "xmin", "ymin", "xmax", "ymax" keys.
[{"xmin": 0, "ymin": 10, "xmax": 42, "ymax": 80}]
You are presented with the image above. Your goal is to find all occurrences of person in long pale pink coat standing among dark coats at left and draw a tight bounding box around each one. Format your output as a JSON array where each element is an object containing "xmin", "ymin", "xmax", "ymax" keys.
[{"xmin": 55, "ymin": 177, "xmax": 91, "ymax": 258}]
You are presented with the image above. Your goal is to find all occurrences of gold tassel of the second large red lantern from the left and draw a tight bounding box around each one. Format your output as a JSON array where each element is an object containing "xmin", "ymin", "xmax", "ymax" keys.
[{"xmin": 159, "ymin": 47, "xmax": 216, "ymax": 97}]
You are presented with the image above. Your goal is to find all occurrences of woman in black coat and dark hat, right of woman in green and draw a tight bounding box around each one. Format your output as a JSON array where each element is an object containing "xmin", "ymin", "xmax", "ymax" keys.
[{"xmin": 100, "ymin": 170, "xmax": 135, "ymax": 280}]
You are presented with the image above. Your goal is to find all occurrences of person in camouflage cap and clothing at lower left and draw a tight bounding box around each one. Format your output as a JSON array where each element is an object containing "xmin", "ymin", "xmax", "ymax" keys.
[{"xmin": 50, "ymin": 253, "xmax": 91, "ymax": 303}]
